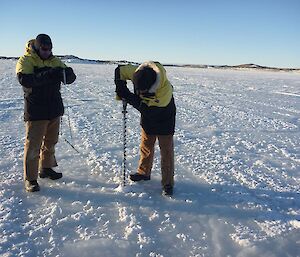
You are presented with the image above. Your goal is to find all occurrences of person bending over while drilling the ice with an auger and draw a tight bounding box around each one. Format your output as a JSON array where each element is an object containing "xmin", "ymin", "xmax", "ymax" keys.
[{"xmin": 115, "ymin": 62, "xmax": 176, "ymax": 195}]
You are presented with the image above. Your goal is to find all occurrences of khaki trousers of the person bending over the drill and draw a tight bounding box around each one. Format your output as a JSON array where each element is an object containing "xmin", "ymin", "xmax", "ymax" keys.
[{"xmin": 138, "ymin": 129, "xmax": 174, "ymax": 186}]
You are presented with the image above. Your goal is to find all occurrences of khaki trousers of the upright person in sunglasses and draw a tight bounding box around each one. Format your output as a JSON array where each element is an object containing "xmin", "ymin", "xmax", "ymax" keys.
[{"xmin": 24, "ymin": 117, "xmax": 60, "ymax": 181}]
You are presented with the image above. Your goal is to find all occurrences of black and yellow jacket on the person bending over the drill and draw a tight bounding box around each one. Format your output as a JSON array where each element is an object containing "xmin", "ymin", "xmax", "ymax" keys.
[{"xmin": 115, "ymin": 62, "xmax": 176, "ymax": 135}]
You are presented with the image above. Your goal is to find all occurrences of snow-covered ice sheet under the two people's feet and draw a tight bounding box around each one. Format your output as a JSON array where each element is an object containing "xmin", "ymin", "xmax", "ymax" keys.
[{"xmin": 0, "ymin": 60, "xmax": 300, "ymax": 257}]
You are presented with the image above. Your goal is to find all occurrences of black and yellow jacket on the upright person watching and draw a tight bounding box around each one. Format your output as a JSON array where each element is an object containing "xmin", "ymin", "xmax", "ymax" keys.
[{"xmin": 16, "ymin": 39, "xmax": 76, "ymax": 121}]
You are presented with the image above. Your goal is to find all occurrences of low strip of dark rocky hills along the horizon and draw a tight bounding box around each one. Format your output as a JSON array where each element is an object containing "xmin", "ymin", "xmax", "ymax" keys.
[{"xmin": 0, "ymin": 55, "xmax": 300, "ymax": 72}]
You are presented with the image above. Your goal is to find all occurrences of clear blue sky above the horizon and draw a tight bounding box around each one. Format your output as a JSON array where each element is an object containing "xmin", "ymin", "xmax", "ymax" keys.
[{"xmin": 0, "ymin": 0, "xmax": 300, "ymax": 68}]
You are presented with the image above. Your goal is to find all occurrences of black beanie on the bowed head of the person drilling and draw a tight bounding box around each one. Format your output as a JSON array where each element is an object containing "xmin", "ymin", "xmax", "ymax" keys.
[{"xmin": 134, "ymin": 67, "xmax": 156, "ymax": 90}]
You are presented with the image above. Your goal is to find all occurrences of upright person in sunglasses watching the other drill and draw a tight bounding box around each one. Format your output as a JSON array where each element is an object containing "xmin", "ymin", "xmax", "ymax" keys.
[{"xmin": 16, "ymin": 34, "xmax": 76, "ymax": 192}]
